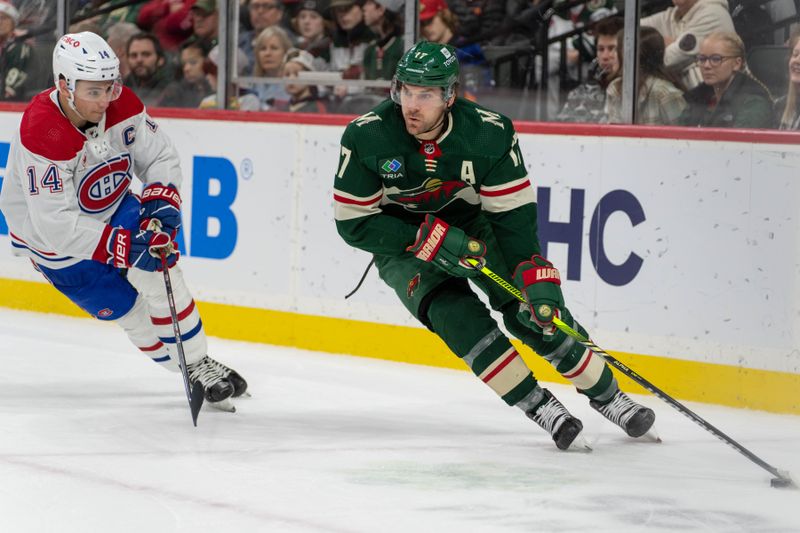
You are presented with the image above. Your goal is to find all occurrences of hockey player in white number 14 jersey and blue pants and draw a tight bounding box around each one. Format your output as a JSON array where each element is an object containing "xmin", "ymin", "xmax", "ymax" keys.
[{"xmin": 0, "ymin": 32, "xmax": 247, "ymax": 405}]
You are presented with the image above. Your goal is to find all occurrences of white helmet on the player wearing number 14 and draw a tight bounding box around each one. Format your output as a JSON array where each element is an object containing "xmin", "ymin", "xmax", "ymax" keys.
[{"xmin": 53, "ymin": 31, "xmax": 122, "ymax": 100}]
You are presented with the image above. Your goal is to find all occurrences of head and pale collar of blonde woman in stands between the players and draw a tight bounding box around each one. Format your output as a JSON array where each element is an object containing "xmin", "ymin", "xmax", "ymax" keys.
[{"xmin": 253, "ymin": 26, "xmax": 292, "ymax": 110}]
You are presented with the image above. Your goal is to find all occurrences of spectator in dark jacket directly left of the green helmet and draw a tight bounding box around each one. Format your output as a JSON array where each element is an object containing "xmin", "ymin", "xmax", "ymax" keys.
[{"xmin": 362, "ymin": 0, "xmax": 406, "ymax": 80}]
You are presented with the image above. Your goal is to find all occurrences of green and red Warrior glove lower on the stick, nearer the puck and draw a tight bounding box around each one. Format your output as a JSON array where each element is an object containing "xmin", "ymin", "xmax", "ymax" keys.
[{"xmin": 514, "ymin": 255, "xmax": 564, "ymax": 337}]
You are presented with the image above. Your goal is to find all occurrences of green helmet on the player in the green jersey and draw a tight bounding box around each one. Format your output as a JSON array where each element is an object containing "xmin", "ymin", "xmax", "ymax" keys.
[{"xmin": 392, "ymin": 41, "xmax": 458, "ymax": 104}]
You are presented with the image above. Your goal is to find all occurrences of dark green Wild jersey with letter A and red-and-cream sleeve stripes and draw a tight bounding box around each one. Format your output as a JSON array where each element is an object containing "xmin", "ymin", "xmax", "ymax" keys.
[{"xmin": 333, "ymin": 98, "xmax": 539, "ymax": 265}]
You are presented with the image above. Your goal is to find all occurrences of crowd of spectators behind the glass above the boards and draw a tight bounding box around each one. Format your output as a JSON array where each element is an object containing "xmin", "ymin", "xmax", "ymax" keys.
[{"xmin": 0, "ymin": 0, "xmax": 800, "ymax": 130}]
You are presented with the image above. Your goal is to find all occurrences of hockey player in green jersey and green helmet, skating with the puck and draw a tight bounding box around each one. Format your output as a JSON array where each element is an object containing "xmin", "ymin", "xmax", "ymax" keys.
[{"xmin": 334, "ymin": 41, "xmax": 655, "ymax": 450}]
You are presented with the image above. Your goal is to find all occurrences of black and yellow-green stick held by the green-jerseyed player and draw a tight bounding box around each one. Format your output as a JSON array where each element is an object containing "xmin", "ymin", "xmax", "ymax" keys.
[{"xmin": 466, "ymin": 258, "xmax": 797, "ymax": 489}]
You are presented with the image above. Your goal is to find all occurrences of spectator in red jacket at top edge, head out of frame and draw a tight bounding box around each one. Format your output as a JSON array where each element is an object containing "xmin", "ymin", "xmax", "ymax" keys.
[{"xmin": 136, "ymin": 0, "xmax": 194, "ymax": 57}]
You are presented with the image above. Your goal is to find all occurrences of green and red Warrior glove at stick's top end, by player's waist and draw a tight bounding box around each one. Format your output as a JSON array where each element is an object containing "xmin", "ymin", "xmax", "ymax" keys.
[{"xmin": 406, "ymin": 215, "xmax": 486, "ymax": 278}]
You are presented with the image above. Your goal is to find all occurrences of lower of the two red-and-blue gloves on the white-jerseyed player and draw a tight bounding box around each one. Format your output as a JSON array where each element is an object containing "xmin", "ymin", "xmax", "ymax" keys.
[{"xmin": 107, "ymin": 228, "xmax": 179, "ymax": 272}]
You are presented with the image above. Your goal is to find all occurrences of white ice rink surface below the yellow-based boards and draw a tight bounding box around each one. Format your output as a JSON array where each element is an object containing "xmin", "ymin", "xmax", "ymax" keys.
[{"xmin": 0, "ymin": 310, "xmax": 800, "ymax": 533}]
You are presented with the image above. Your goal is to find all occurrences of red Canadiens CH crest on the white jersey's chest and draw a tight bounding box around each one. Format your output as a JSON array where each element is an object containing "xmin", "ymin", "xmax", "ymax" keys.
[{"xmin": 78, "ymin": 154, "xmax": 131, "ymax": 213}]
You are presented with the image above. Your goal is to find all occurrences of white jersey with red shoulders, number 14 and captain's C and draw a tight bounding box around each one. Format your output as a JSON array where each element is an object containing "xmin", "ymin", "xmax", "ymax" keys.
[{"xmin": 0, "ymin": 88, "xmax": 181, "ymax": 268}]
